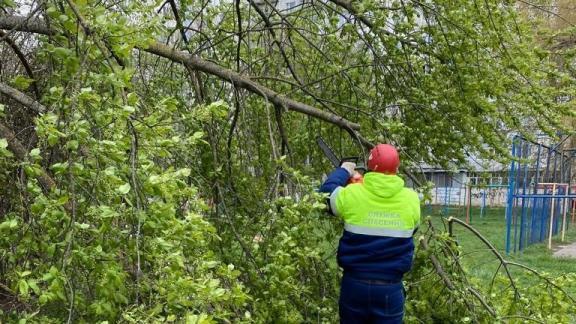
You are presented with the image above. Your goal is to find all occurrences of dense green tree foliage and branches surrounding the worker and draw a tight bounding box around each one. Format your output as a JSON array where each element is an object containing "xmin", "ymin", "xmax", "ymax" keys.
[{"xmin": 0, "ymin": 0, "xmax": 573, "ymax": 323}]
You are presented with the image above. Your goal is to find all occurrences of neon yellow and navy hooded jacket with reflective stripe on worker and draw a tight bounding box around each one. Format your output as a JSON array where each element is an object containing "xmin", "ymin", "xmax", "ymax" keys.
[{"xmin": 320, "ymin": 168, "xmax": 420, "ymax": 281}]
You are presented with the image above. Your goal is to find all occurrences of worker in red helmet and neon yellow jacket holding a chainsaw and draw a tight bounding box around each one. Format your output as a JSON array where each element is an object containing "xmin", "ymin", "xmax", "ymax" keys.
[{"xmin": 320, "ymin": 144, "xmax": 420, "ymax": 323}]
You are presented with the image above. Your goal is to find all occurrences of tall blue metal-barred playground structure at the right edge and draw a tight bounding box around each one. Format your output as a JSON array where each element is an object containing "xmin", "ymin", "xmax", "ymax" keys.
[{"xmin": 506, "ymin": 136, "xmax": 576, "ymax": 253}]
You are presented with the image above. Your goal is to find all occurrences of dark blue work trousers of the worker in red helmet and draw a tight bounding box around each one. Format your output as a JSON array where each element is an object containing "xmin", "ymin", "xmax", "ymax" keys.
[{"xmin": 340, "ymin": 274, "xmax": 404, "ymax": 324}]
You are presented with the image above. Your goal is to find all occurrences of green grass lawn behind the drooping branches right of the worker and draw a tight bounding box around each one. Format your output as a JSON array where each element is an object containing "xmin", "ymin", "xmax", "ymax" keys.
[{"xmin": 423, "ymin": 207, "xmax": 576, "ymax": 296}]
